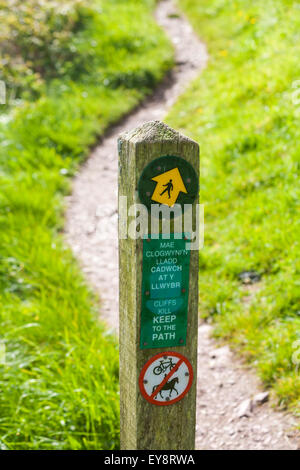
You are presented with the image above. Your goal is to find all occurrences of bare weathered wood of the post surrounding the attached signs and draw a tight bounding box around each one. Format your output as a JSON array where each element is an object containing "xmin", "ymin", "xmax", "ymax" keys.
[{"xmin": 119, "ymin": 121, "xmax": 199, "ymax": 450}]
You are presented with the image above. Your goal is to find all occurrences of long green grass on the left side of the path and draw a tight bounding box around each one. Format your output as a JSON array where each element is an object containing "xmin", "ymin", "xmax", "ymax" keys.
[{"xmin": 0, "ymin": 0, "xmax": 172, "ymax": 449}]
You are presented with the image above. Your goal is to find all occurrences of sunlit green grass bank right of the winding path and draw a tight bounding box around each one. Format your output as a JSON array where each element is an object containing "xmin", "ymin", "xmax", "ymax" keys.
[{"xmin": 168, "ymin": 0, "xmax": 300, "ymax": 413}]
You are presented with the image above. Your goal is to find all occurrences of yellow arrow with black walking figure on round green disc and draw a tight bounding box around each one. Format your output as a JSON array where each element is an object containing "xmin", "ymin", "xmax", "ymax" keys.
[{"xmin": 151, "ymin": 168, "xmax": 187, "ymax": 207}]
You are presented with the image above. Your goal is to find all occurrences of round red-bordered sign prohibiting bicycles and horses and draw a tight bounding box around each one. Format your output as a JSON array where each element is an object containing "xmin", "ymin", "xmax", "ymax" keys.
[{"xmin": 139, "ymin": 352, "xmax": 193, "ymax": 406}]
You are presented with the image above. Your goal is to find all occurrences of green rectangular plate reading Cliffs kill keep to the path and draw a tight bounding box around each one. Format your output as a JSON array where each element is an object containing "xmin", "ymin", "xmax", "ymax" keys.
[{"xmin": 140, "ymin": 234, "xmax": 190, "ymax": 349}]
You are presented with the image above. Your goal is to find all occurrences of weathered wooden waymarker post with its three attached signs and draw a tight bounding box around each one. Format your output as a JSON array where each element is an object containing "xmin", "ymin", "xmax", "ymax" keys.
[{"xmin": 119, "ymin": 121, "xmax": 199, "ymax": 450}]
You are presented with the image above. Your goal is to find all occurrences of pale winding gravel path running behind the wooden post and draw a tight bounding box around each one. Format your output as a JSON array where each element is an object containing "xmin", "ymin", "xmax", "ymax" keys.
[{"xmin": 66, "ymin": 0, "xmax": 299, "ymax": 449}]
